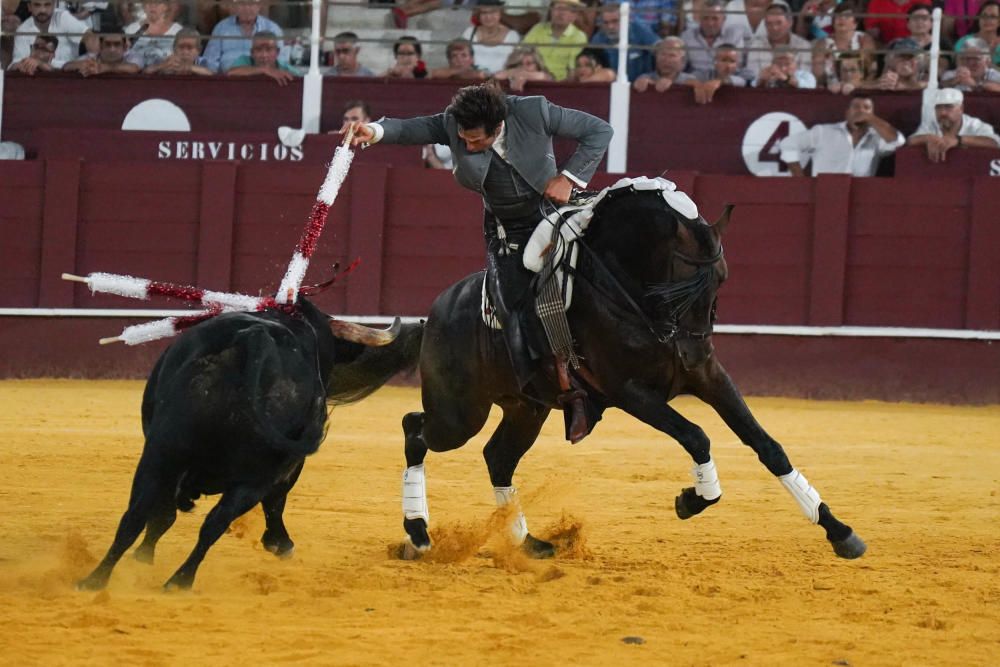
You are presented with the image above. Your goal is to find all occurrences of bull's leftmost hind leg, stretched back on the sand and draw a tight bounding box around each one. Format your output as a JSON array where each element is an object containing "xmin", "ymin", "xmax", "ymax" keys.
[{"xmin": 76, "ymin": 454, "xmax": 169, "ymax": 591}]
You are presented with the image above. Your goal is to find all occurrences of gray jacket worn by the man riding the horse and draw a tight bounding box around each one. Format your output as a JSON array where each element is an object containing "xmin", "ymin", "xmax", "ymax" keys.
[{"xmin": 379, "ymin": 95, "xmax": 613, "ymax": 194}]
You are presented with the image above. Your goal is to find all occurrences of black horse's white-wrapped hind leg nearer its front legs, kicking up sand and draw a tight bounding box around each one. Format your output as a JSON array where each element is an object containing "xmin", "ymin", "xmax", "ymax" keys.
[{"xmin": 483, "ymin": 403, "xmax": 555, "ymax": 558}]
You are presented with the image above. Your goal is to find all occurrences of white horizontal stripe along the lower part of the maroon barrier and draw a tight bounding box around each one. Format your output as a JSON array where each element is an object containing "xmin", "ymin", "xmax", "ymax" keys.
[{"xmin": 0, "ymin": 308, "xmax": 1000, "ymax": 340}]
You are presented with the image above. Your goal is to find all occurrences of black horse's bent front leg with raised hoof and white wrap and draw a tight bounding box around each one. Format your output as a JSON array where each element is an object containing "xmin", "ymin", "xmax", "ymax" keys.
[{"xmin": 618, "ymin": 381, "xmax": 722, "ymax": 519}]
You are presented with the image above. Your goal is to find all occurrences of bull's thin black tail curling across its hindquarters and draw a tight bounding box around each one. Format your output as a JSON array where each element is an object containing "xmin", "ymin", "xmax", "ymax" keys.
[{"xmin": 240, "ymin": 324, "xmax": 327, "ymax": 456}]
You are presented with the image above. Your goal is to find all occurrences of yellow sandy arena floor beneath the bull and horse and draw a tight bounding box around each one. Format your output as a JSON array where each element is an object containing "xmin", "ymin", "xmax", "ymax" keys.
[{"xmin": 0, "ymin": 381, "xmax": 1000, "ymax": 667}]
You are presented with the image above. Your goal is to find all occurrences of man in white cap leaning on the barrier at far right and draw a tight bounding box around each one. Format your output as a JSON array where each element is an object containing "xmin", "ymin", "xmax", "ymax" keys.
[{"xmin": 906, "ymin": 88, "xmax": 1000, "ymax": 162}]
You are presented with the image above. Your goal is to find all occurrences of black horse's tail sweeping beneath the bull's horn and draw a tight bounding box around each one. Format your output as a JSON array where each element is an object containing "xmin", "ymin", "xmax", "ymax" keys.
[{"xmin": 326, "ymin": 322, "xmax": 424, "ymax": 405}]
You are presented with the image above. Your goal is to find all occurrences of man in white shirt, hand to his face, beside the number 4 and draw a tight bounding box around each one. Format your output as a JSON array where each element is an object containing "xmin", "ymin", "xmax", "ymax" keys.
[{"xmin": 781, "ymin": 97, "xmax": 903, "ymax": 176}]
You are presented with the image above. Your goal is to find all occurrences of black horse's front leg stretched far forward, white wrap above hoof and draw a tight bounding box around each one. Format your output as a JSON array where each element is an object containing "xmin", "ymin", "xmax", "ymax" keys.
[{"xmin": 694, "ymin": 359, "xmax": 867, "ymax": 558}]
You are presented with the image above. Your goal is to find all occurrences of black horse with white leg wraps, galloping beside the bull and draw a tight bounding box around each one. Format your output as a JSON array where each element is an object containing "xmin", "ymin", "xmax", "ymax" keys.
[{"xmin": 403, "ymin": 188, "xmax": 866, "ymax": 558}]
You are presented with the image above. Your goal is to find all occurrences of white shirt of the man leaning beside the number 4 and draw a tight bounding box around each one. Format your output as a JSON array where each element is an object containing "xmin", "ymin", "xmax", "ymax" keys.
[{"xmin": 781, "ymin": 121, "xmax": 904, "ymax": 176}]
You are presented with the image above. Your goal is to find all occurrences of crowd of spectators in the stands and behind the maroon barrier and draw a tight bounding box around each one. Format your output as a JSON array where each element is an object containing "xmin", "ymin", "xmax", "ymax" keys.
[{"xmin": 2, "ymin": 0, "xmax": 1000, "ymax": 175}]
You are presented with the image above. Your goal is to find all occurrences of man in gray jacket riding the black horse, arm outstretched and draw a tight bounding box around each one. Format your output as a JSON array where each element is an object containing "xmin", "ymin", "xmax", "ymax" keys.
[{"xmin": 342, "ymin": 83, "xmax": 612, "ymax": 442}]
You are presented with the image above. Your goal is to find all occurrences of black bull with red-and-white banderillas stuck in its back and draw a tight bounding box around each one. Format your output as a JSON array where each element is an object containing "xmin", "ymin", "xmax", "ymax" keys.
[{"xmin": 79, "ymin": 299, "xmax": 423, "ymax": 589}]
